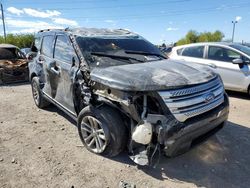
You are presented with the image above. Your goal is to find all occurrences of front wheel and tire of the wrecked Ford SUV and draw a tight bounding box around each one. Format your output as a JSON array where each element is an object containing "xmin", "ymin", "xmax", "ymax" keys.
[{"xmin": 77, "ymin": 106, "xmax": 128, "ymax": 157}]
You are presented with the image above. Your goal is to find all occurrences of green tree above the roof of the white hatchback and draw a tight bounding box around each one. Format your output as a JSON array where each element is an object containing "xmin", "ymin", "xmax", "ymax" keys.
[{"xmin": 177, "ymin": 30, "xmax": 224, "ymax": 45}]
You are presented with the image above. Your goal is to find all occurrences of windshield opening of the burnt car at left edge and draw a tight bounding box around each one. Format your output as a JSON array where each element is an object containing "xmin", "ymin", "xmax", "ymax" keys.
[{"xmin": 0, "ymin": 48, "xmax": 25, "ymax": 60}]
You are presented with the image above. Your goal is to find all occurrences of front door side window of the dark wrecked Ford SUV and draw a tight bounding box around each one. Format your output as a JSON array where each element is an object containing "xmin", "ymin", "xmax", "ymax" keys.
[{"xmin": 54, "ymin": 35, "xmax": 76, "ymax": 64}]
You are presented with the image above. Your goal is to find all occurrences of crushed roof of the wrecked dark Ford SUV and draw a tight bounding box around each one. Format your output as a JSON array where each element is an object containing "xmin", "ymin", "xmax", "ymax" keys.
[{"xmin": 39, "ymin": 28, "xmax": 137, "ymax": 36}]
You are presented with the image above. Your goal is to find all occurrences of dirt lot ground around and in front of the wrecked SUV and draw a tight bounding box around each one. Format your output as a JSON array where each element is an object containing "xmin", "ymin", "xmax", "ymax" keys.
[{"xmin": 0, "ymin": 85, "xmax": 250, "ymax": 188}]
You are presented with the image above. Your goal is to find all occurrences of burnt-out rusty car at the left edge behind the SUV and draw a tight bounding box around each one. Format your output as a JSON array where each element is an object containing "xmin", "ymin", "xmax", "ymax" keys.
[{"xmin": 0, "ymin": 44, "xmax": 29, "ymax": 85}]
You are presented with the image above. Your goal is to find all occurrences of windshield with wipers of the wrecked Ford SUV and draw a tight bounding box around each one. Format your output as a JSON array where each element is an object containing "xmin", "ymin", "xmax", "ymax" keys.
[{"xmin": 76, "ymin": 37, "xmax": 162, "ymax": 67}]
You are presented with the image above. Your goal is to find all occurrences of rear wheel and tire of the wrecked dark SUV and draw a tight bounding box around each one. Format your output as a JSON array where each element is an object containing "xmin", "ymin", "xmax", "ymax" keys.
[{"xmin": 31, "ymin": 77, "xmax": 50, "ymax": 108}]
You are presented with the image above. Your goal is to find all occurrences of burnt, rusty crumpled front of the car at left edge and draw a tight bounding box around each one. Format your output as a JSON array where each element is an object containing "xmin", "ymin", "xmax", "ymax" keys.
[{"xmin": 0, "ymin": 59, "xmax": 29, "ymax": 84}]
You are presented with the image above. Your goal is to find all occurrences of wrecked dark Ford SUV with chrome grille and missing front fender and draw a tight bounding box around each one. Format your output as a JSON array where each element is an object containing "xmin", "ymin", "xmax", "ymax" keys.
[{"xmin": 29, "ymin": 28, "xmax": 229, "ymax": 165}]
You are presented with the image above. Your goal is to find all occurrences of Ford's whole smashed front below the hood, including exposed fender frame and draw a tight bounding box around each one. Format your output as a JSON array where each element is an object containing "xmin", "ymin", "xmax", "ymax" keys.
[{"xmin": 93, "ymin": 76, "xmax": 229, "ymax": 165}]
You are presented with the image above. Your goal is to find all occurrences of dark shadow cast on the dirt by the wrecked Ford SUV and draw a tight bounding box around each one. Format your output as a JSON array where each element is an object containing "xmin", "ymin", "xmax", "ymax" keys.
[{"xmin": 42, "ymin": 105, "xmax": 250, "ymax": 188}]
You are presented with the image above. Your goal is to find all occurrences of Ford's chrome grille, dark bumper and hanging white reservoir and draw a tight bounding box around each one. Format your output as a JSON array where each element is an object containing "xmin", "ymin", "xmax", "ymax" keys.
[{"xmin": 130, "ymin": 77, "xmax": 229, "ymax": 165}]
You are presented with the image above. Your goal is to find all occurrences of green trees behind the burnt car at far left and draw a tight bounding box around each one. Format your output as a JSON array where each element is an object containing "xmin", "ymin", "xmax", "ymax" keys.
[{"xmin": 0, "ymin": 34, "xmax": 34, "ymax": 48}]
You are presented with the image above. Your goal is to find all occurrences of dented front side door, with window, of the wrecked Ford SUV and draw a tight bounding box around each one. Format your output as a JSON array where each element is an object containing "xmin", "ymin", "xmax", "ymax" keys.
[{"xmin": 54, "ymin": 35, "xmax": 79, "ymax": 114}]
